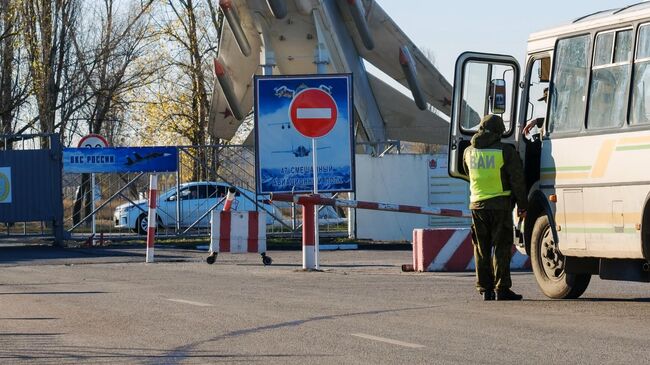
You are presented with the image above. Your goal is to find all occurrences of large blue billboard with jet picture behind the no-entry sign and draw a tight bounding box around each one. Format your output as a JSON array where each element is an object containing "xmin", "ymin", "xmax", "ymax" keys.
[{"xmin": 255, "ymin": 74, "xmax": 355, "ymax": 194}]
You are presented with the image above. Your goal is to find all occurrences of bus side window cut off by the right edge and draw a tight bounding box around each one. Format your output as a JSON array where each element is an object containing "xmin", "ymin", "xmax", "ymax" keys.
[{"xmin": 630, "ymin": 24, "xmax": 650, "ymax": 124}]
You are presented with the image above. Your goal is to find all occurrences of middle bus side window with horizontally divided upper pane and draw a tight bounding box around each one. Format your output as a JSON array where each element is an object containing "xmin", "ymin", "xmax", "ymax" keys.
[{"xmin": 587, "ymin": 29, "xmax": 633, "ymax": 129}]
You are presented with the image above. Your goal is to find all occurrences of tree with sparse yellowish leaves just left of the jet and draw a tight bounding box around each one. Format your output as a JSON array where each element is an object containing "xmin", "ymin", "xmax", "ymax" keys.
[{"xmin": 133, "ymin": 0, "xmax": 220, "ymax": 180}]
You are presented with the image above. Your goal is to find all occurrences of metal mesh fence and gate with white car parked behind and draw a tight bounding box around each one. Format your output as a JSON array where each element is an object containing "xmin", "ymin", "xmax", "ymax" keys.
[{"xmin": 63, "ymin": 145, "xmax": 347, "ymax": 240}]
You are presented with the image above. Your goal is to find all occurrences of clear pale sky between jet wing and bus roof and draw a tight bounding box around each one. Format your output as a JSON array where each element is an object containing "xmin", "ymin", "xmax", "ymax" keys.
[{"xmin": 377, "ymin": 0, "xmax": 640, "ymax": 82}]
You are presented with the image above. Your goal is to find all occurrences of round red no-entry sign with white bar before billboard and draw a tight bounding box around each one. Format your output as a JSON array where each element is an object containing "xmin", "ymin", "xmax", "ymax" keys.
[{"xmin": 289, "ymin": 89, "xmax": 338, "ymax": 138}]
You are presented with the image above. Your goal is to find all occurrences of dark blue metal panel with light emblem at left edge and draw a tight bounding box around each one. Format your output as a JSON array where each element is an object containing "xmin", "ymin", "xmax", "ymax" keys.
[{"xmin": 0, "ymin": 134, "xmax": 63, "ymax": 245}]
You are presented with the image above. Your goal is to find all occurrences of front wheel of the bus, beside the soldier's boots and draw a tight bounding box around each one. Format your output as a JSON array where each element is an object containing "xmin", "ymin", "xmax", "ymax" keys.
[{"xmin": 531, "ymin": 214, "xmax": 591, "ymax": 299}]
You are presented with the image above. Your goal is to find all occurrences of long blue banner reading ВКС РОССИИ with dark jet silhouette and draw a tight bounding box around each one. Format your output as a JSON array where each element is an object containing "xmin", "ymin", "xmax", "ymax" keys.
[{"xmin": 63, "ymin": 147, "xmax": 178, "ymax": 173}]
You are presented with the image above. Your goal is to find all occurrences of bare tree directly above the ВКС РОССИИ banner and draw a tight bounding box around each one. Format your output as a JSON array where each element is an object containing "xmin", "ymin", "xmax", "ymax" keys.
[{"xmin": 72, "ymin": 0, "xmax": 156, "ymax": 143}]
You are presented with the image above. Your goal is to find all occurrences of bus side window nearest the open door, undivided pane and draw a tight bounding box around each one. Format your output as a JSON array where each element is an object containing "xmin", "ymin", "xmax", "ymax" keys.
[{"xmin": 548, "ymin": 35, "xmax": 590, "ymax": 133}]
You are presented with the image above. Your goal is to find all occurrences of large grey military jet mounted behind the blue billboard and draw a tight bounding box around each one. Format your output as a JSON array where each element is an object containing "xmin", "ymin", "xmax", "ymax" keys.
[{"xmin": 209, "ymin": 0, "xmax": 452, "ymax": 148}]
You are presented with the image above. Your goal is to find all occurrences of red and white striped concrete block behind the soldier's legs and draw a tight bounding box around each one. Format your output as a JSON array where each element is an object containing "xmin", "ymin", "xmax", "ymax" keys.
[{"xmin": 413, "ymin": 228, "xmax": 530, "ymax": 271}]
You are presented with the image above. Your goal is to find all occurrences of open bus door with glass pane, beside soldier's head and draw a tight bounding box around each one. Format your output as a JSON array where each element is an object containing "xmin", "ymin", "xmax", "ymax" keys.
[{"xmin": 448, "ymin": 52, "xmax": 520, "ymax": 180}]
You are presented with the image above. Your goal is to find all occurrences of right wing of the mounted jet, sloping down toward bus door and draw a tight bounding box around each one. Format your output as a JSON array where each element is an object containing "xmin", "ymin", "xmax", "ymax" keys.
[{"xmin": 337, "ymin": 0, "xmax": 452, "ymax": 116}]
